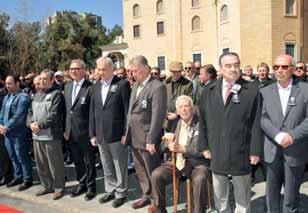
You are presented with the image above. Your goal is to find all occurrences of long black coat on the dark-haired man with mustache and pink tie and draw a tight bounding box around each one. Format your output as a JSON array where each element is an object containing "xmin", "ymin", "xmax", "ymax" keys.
[{"xmin": 199, "ymin": 79, "xmax": 262, "ymax": 175}]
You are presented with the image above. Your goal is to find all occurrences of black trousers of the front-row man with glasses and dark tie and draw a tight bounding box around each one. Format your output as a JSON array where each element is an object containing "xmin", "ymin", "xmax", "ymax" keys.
[{"xmin": 69, "ymin": 135, "xmax": 96, "ymax": 192}]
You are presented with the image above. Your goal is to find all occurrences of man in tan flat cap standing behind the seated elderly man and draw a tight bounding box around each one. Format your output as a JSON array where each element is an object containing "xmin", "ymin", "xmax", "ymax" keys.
[{"xmin": 164, "ymin": 61, "xmax": 193, "ymax": 131}]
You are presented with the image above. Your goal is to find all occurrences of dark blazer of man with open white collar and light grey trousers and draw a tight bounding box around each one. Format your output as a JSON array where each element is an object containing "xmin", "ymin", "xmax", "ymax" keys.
[{"xmin": 89, "ymin": 76, "xmax": 131, "ymax": 143}]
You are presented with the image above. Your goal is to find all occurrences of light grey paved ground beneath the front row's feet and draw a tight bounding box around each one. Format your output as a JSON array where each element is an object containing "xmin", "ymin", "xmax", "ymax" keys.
[{"xmin": 0, "ymin": 163, "xmax": 308, "ymax": 213}]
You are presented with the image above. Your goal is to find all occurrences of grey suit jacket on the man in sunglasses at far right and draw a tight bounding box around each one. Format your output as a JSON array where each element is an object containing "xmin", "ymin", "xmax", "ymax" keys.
[{"xmin": 261, "ymin": 80, "xmax": 308, "ymax": 166}]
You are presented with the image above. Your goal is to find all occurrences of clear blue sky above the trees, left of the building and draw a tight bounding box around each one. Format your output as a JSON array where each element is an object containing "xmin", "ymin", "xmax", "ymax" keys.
[{"xmin": 0, "ymin": 0, "xmax": 123, "ymax": 29}]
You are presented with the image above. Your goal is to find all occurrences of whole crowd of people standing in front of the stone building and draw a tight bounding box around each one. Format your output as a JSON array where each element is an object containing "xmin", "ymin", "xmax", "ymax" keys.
[{"xmin": 0, "ymin": 52, "xmax": 308, "ymax": 213}]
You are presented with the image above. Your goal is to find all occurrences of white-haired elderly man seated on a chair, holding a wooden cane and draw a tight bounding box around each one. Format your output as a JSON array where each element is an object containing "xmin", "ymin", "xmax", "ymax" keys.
[{"xmin": 148, "ymin": 95, "xmax": 209, "ymax": 213}]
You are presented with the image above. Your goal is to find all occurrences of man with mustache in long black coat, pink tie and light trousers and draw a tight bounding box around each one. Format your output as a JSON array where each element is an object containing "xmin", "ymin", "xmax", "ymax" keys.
[{"xmin": 199, "ymin": 52, "xmax": 262, "ymax": 213}]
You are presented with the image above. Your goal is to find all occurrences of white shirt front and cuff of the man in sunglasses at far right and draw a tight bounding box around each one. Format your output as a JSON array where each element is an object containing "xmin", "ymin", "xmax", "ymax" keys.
[{"xmin": 275, "ymin": 79, "xmax": 292, "ymax": 144}]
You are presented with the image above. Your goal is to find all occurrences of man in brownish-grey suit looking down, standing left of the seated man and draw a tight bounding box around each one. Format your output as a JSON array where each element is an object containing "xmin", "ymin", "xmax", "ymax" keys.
[{"xmin": 126, "ymin": 56, "xmax": 166, "ymax": 209}]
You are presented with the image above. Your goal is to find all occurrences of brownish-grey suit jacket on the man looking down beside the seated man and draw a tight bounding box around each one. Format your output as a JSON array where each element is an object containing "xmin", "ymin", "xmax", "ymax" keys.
[{"xmin": 126, "ymin": 77, "xmax": 167, "ymax": 149}]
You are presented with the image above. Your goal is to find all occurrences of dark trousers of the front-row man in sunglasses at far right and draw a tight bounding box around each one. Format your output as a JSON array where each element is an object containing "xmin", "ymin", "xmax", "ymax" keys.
[{"xmin": 266, "ymin": 150, "xmax": 305, "ymax": 213}]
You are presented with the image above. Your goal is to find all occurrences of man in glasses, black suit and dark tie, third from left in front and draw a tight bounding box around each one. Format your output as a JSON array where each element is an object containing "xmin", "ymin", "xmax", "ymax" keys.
[{"xmin": 64, "ymin": 59, "xmax": 96, "ymax": 201}]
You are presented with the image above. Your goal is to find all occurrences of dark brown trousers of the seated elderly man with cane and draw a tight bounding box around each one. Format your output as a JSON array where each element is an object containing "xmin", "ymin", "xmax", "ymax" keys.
[{"xmin": 151, "ymin": 162, "xmax": 209, "ymax": 213}]
